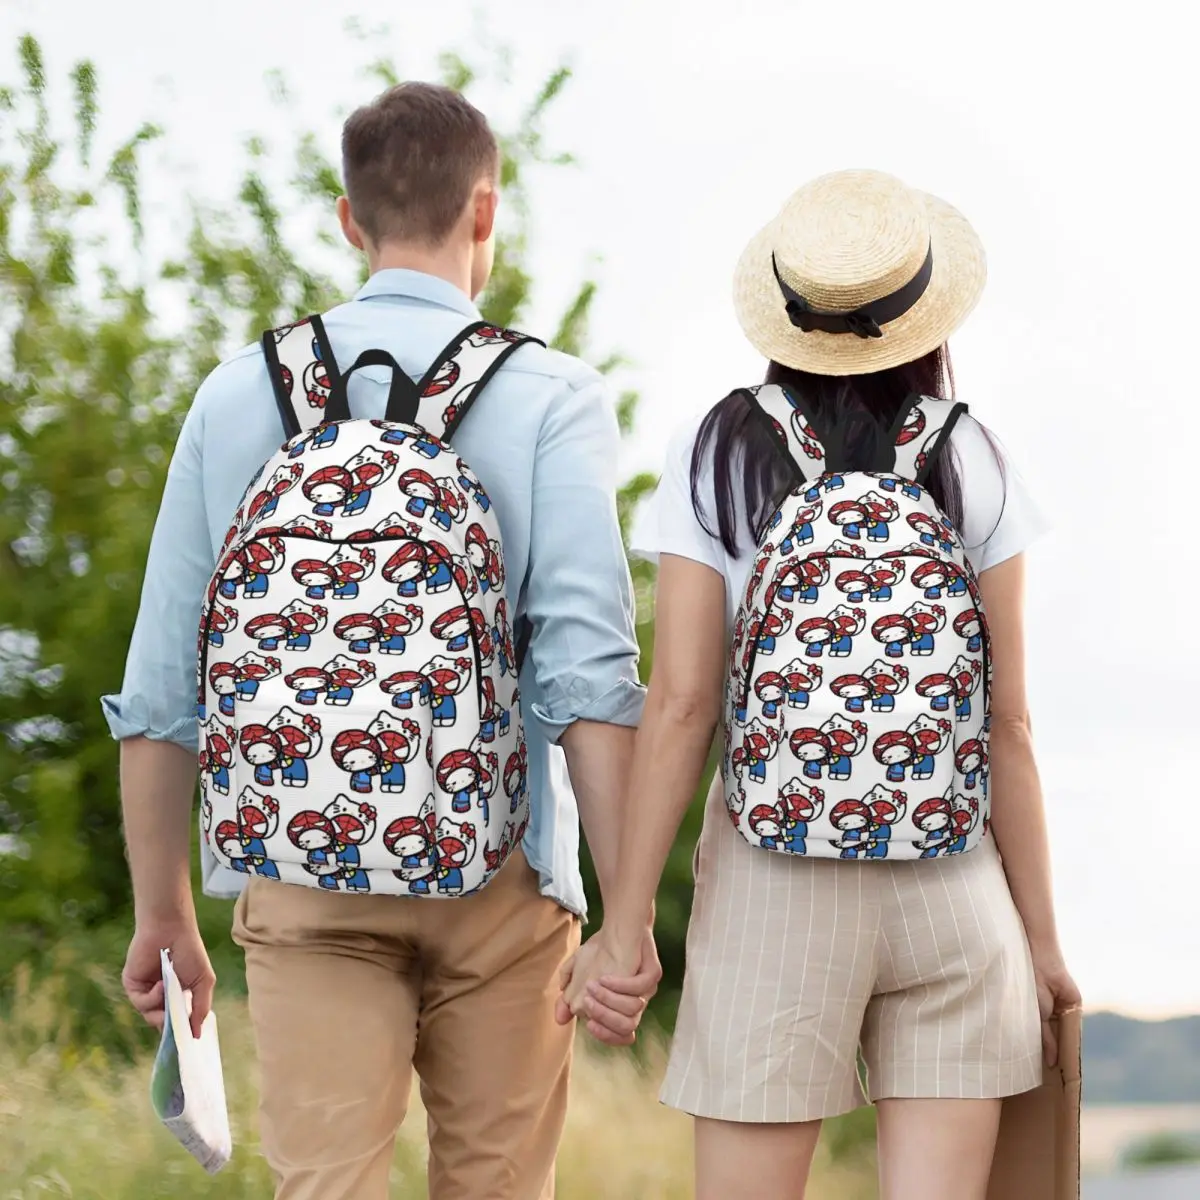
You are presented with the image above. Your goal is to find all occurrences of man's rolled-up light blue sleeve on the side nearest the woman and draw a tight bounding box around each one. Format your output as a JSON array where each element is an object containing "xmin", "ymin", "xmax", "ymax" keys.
[{"xmin": 526, "ymin": 377, "xmax": 644, "ymax": 742}]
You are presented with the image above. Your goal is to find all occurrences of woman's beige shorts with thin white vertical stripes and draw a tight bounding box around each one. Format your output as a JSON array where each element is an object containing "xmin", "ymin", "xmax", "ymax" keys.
[{"xmin": 661, "ymin": 784, "xmax": 1042, "ymax": 1122}]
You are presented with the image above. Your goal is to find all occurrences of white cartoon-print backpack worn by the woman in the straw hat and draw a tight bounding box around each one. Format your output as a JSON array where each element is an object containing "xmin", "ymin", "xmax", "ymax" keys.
[{"xmin": 724, "ymin": 385, "xmax": 991, "ymax": 859}]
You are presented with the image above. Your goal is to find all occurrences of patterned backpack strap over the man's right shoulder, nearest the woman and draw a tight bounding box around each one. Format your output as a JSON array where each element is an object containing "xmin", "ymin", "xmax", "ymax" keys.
[{"xmin": 410, "ymin": 320, "xmax": 546, "ymax": 442}]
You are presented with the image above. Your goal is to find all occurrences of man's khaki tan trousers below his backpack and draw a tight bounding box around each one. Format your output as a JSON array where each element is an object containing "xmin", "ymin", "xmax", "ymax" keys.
[{"xmin": 234, "ymin": 851, "xmax": 580, "ymax": 1200}]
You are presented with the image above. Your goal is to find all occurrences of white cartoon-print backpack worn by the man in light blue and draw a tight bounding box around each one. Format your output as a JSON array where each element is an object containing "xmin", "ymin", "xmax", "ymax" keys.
[{"xmin": 198, "ymin": 317, "xmax": 534, "ymax": 896}]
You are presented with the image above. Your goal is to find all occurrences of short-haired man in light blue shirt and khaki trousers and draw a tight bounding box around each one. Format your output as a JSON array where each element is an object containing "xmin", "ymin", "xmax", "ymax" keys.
[{"xmin": 104, "ymin": 84, "xmax": 659, "ymax": 1200}]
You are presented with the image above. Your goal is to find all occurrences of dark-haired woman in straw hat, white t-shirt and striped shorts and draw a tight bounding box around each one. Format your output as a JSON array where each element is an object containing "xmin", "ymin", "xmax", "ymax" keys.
[{"xmin": 565, "ymin": 172, "xmax": 1079, "ymax": 1200}]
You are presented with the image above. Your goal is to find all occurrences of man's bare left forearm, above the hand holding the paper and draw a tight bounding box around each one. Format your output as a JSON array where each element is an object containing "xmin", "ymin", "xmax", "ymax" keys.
[{"xmin": 121, "ymin": 738, "xmax": 196, "ymax": 923}]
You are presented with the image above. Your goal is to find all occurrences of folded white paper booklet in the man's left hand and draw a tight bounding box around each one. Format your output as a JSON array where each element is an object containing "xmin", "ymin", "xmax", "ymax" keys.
[{"xmin": 150, "ymin": 950, "xmax": 233, "ymax": 1175}]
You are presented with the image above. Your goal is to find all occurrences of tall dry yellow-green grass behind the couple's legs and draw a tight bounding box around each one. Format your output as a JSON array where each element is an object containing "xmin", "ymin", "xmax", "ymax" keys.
[{"xmin": 0, "ymin": 971, "xmax": 875, "ymax": 1200}]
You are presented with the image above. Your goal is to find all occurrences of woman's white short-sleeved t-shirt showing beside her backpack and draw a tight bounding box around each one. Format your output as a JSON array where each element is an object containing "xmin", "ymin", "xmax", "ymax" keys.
[{"xmin": 632, "ymin": 415, "xmax": 1046, "ymax": 629}]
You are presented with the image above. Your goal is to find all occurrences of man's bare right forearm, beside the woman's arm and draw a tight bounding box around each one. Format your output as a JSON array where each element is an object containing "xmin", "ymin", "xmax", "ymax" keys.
[{"xmin": 560, "ymin": 721, "xmax": 635, "ymax": 907}]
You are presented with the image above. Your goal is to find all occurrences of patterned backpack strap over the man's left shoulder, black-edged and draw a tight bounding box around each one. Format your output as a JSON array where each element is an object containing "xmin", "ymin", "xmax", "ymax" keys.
[{"xmin": 255, "ymin": 316, "xmax": 350, "ymax": 438}]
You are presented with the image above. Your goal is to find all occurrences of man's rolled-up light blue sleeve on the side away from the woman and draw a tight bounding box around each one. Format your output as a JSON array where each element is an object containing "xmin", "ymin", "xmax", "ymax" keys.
[{"xmin": 101, "ymin": 388, "xmax": 215, "ymax": 749}]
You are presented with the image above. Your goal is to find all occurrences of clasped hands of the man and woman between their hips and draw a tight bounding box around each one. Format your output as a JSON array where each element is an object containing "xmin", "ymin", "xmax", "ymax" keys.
[{"xmin": 556, "ymin": 929, "xmax": 662, "ymax": 1046}]
